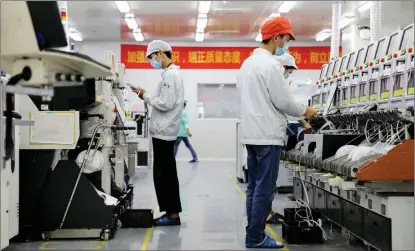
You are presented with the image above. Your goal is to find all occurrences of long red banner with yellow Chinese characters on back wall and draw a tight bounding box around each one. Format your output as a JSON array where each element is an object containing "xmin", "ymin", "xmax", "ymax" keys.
[{"xmin": 121, "ymin": 44, "xmax": 341, "ymax": 70}]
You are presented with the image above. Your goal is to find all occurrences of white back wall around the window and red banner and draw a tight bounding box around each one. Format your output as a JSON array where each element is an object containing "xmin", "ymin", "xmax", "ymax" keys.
[{"xmin": 75, "ymin": 42, "xmax": 327, "ymax": 160}]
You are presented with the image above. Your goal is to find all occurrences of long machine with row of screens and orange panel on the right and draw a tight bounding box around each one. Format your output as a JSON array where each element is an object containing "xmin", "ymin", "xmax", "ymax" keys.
[{"xmin": 285, "ymin": 25, "xmax": 415, "ymax": 250}]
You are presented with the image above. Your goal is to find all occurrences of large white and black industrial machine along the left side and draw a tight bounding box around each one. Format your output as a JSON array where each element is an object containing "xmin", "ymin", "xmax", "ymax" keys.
[{"xmin": 0, "ymin": 1, "xmax": 146, "ymax": 249}]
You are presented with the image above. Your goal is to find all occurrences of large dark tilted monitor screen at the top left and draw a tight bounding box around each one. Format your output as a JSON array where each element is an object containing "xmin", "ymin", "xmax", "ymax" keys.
[{"xmin": 26, "ymin": 1, "xmax": 68, "ymax": 50}]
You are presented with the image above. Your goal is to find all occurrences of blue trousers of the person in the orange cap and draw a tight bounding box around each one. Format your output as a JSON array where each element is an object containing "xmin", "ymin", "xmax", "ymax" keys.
[{"xmin": 246, "ymin": 145, "xmax": 281, "ymax": 243}]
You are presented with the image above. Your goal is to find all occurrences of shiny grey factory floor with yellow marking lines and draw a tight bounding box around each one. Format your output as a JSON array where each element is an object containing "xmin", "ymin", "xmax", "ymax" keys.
[{"xmin": 6, "ymin": 162, "xmax": 365, "ymax": 251}]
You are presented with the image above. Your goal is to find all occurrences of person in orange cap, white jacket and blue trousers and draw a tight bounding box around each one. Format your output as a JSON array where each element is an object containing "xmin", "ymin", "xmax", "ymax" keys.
[{"xmin": 238, "ymin": 17, "xmax": 317, "ymax": 248}]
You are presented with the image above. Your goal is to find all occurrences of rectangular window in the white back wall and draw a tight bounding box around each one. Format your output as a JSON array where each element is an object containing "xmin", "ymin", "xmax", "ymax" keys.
[{"xmin": 197, "ymin": 84, "xmax": 240, "ymax": 119}]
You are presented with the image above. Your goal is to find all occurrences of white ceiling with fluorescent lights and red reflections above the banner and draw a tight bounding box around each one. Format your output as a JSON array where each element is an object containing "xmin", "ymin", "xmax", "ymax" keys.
[{"xmin": 67, "ymin": 1, "xmax": 413, "ymax": 42}]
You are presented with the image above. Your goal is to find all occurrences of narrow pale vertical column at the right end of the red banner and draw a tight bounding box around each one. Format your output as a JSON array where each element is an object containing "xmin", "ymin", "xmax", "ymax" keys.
[{"xmin": 330, "ymin": 1, "xmax": 342, "ymax": 61}]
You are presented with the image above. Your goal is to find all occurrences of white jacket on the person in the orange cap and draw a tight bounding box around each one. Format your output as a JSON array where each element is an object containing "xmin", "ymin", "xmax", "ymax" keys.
[{"xmin": 238, "ymin": 48, "xmax": 306, "ymax": 146}]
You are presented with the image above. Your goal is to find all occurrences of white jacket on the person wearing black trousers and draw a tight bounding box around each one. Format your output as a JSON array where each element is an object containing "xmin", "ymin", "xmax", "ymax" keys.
[{"xmin": 144, "ymin": 65, "xmax": 184, "ymax": 141}]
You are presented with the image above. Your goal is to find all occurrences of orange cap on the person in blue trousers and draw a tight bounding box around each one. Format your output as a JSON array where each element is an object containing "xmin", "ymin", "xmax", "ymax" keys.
[{"xmin": 261, "ymin": 17, "xmax": 295, "ymax": 40}]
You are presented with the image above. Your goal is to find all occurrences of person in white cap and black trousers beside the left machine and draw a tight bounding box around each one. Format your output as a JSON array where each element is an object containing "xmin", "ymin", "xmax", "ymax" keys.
[{"xmin": 129, "ymin": 40, "xmax": 184, "ymax": 226}]
